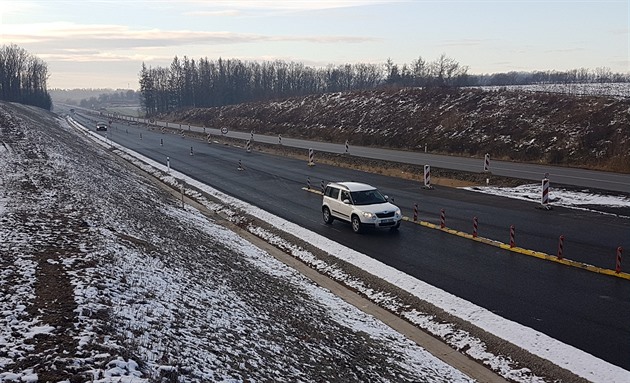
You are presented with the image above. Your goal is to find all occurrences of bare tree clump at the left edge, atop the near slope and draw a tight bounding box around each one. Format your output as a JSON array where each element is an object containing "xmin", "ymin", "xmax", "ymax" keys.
[{"xmin": 0, "ymin": 44, "xmax": 52, "ymax": 110}]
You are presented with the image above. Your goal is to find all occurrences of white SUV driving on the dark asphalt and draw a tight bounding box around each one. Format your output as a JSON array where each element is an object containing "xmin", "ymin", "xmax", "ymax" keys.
[{"xmin": 322, "ymin": 182, "xmax": 402, "ymax": 233}]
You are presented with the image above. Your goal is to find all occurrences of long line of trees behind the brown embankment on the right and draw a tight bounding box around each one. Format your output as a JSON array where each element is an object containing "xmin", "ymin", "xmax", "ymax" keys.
[{"xmin": 139, "ymin": 55, "xmax": 630, "ymax": 116}]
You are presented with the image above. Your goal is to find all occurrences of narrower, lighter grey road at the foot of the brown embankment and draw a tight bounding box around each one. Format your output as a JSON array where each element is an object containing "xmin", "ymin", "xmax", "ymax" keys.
[{"xmin": 113, "ymin": 113, "xmax": 630, "ymax": 193}]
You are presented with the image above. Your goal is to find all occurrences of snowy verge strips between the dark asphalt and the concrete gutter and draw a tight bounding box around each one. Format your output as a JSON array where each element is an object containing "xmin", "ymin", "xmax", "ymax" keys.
[{"xmin": 74, "ymin": 118, "xmax": 630, "ymax": 382}]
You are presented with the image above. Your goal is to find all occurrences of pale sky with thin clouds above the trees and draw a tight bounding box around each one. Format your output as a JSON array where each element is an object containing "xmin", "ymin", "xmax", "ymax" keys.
[{"xmin": 0, "ymin": 0, "xmax": 630, "ymax": 89}]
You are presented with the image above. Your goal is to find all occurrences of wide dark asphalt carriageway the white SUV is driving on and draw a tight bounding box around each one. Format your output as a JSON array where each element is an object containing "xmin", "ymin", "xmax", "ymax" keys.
[{"xmin": 76, "ymin": 112, "xmax": 630, "ymax": 370}]
